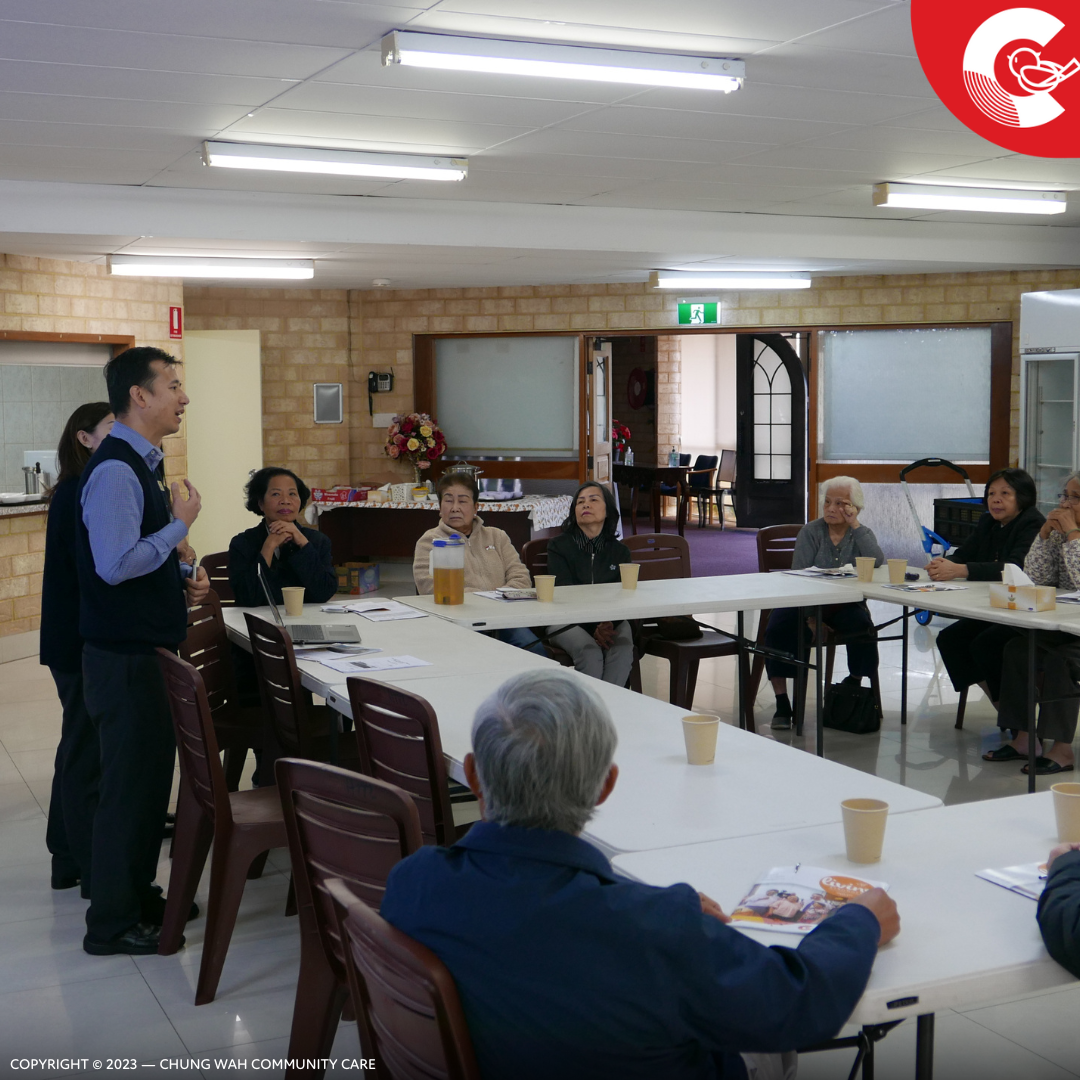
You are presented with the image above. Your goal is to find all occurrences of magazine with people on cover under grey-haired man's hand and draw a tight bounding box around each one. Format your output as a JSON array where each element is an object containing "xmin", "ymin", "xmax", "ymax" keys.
[{"xmin": 731, "ymin": 864, "xmax": 889, "ymax": 934}]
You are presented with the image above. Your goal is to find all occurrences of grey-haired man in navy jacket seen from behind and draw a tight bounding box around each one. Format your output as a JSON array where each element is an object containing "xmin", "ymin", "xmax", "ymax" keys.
[{"xmin": 382, "ymin": 672, "xmax": 900, "ymax": 1080}]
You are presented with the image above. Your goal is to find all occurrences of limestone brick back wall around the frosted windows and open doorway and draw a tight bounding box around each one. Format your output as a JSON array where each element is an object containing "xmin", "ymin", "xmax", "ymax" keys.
[{"xmin": 350, "ymin": 270, "xmax": 1080, "ymax": 476}]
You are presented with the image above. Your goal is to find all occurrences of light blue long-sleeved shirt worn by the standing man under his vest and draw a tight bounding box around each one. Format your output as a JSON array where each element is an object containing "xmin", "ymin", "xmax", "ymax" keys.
[{"xmin": 82, "ymin": 420, "xmax": 191, "ymax": 585}]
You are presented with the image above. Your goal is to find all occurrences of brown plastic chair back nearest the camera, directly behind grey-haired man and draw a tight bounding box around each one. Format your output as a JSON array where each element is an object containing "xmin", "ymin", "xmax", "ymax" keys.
[{"xmin": 326, "ymin": 878, "xmax": 481, "ymax": 1080}]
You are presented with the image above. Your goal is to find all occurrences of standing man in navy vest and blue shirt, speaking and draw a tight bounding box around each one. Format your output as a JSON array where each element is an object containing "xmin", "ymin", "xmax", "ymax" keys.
[{"xmin": 76, "ymin": 348, "xmax": 210, "ymax": 956}]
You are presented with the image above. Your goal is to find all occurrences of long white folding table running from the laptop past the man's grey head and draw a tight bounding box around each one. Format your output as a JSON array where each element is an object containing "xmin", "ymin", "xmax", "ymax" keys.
[{"xmin": 226, "ymin": 608, "xmax": 941, "ymax": 853}]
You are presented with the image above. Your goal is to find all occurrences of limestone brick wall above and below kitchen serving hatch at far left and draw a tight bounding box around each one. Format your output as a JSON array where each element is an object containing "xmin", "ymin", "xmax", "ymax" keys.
[{"xmin": 0, "ymin": 255, "xmax": 187, "ymax": 639}]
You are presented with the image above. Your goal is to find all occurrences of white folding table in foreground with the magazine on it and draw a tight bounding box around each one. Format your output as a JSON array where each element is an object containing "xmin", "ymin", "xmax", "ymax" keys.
[{"xmin": 613, "ymin": 792, "xmax": 1076, "ymax": 1080}]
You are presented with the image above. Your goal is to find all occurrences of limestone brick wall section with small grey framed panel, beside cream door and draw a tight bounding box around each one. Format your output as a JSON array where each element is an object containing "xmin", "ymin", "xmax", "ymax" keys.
[{"xmin": 184, "ymin": 286, "xmax": 354, "ymax": 487}]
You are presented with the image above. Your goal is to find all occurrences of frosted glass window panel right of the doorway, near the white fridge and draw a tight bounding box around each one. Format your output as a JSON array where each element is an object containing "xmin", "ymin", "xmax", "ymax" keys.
[{"xmin": 820, "ymin": 327, "xmax": 990, "ymax": 462}]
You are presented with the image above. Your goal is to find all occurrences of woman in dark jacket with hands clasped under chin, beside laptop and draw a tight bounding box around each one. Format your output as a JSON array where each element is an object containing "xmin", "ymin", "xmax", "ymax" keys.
[{"xmin": 229, "ymin": 468, "xmax": 337, "ymax": 607}]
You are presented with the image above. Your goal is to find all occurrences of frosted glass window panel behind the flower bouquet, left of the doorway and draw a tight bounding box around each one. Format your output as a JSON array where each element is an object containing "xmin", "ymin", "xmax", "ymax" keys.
[{"xmin": 435, "ymin": 337, "xmax": 578, "ymax": 458}]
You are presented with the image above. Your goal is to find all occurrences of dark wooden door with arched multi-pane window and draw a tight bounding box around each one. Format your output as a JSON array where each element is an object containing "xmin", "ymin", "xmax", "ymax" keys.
[{"xmin": 734, "ymin": 334, "xmax": 808, "ymax": 528}]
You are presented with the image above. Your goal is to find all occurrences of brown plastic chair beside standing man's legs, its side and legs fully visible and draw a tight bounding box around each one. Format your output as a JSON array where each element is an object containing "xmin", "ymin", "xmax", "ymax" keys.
[{"xmin": 158, "ymin": 649, "xmax": 287, "ymax": 1005}]
